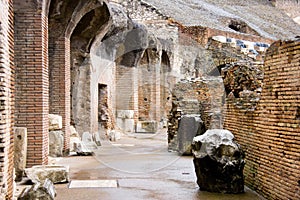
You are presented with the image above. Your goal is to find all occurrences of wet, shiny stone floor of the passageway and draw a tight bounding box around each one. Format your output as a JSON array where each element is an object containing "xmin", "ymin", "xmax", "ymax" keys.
[{"xmin": 17, "ymin": 131, "xmax": 263, "ymax": 200}]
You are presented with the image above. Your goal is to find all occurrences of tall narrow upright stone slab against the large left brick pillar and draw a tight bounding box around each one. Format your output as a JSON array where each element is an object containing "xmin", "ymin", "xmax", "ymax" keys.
[{"xmin": 14, "ymin": 127, "xmax": 27, "ymax": 181}]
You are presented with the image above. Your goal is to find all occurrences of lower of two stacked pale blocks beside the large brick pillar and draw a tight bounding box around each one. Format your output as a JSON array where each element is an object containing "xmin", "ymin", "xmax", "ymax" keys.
[{"xmin": 49, "ymin": 131, "xmax": 64, "ymax": 157}]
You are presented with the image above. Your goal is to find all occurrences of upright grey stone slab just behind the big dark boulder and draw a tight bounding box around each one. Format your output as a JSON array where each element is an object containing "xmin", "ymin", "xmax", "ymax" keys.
[{"xmin": 177, "ymin": 115, "xmax": 205, "ymax": 155}]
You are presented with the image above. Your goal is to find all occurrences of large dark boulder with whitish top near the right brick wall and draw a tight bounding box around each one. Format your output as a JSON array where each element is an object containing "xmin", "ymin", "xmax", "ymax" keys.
[{"xmin": 192, "ymin": 129, "xmax": 245, "ymax": 193}]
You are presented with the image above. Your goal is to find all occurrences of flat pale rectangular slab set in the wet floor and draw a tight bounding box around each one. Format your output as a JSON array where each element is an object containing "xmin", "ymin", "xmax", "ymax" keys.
[{"xmin": 69, "ymin": 180, "xmax": 118, "ymax": 188}]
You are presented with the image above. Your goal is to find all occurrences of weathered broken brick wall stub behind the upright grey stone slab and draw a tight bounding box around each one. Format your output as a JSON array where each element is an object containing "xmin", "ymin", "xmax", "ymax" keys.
[{"xmin": 168, "ymin": 77, "xmax": 224, "ymax": 150}]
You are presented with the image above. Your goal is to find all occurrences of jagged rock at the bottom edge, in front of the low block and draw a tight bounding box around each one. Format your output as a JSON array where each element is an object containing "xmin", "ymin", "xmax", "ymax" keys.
[{"xmin": 18, "ymin": 179, "xmax": 56, "ymax": 200}]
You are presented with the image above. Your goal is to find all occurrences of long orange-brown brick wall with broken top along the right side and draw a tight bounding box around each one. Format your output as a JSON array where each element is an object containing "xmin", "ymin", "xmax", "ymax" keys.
[{"xmin": 224, "ymin": 40, "xmax": 300, "ymax": 199}]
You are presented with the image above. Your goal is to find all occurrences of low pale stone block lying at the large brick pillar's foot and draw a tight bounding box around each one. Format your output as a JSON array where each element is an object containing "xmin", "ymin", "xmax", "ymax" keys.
[{"xmin": 25, "ymin": 165, "xmax": 69, "ymax": 183}]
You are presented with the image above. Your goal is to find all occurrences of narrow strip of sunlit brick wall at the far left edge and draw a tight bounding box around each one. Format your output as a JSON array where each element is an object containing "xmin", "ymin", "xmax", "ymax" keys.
[{"xmin": 0, "ymin": 0, "xmax": 15, "ymax": 199}]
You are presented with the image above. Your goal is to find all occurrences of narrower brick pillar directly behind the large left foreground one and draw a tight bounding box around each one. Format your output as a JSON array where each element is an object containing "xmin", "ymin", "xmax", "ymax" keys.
[{"xmin": 49, "ymin": 36, "xmax": 71, "ymax": 154}]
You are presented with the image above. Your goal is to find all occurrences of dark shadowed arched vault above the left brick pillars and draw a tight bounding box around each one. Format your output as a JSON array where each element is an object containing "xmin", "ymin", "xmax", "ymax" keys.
[{"xmin": 48, "ymin": 0, "xmax": 111, "ymax": 52}]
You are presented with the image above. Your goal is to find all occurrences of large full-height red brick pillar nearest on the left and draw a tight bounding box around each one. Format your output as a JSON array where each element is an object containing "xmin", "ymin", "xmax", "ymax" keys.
[{"xmin": 14, "ymin": 1, "xmax": 49, "ymax": 167}]
